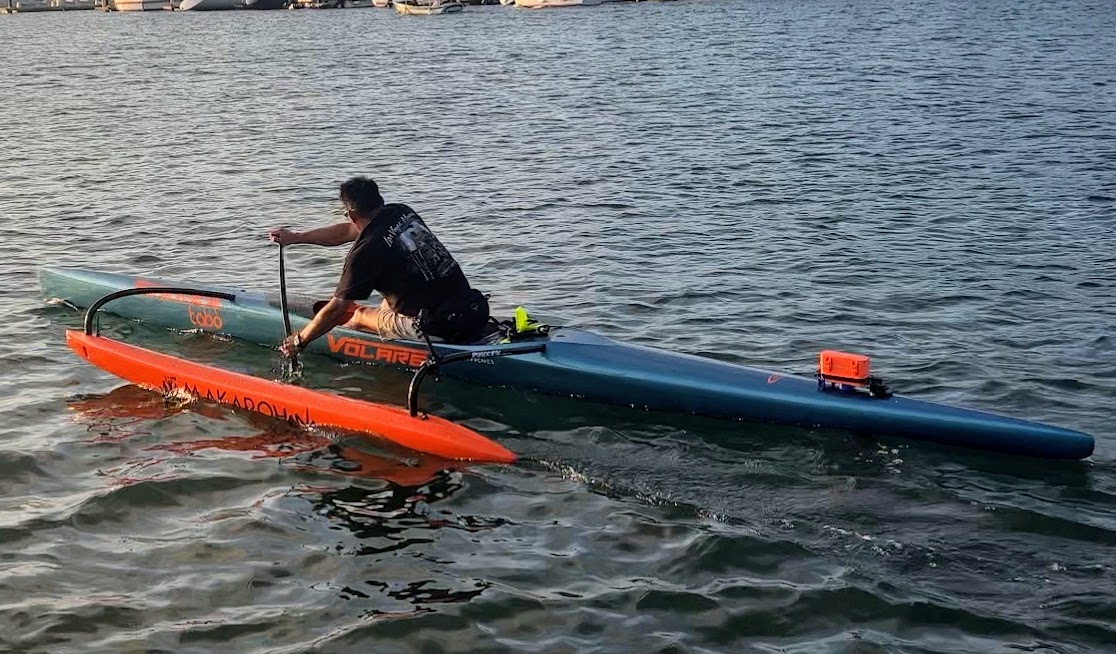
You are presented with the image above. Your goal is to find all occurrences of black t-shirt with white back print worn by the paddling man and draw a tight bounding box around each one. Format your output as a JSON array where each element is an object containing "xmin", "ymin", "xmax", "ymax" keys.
[{"xmin": 334, "ymin": 204, "xmax": 469, "ymax": 316}]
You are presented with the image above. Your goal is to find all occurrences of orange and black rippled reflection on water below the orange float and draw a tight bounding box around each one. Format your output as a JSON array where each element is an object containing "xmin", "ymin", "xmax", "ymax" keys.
[{"xmin": 68, "ymin": 385, "xmax": 497, "ymax": 622}]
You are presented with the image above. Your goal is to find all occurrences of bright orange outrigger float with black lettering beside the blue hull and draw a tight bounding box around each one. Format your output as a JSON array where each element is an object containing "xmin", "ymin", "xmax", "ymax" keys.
[{"xmin": 66, "ymin": 329, "xmax": 516, "ymax": 463}]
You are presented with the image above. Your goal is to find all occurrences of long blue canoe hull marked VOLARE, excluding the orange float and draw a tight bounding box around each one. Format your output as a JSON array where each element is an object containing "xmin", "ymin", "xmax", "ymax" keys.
[{"xmin": 40, "ymin": 268, "xmax": 1094, "ymax": 459}]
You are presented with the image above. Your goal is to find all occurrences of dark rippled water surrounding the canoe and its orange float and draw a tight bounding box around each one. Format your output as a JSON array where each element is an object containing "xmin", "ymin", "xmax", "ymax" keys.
[{"xmin": 0, "ymin": 0, "xmax": 1116, "ymax": 653}]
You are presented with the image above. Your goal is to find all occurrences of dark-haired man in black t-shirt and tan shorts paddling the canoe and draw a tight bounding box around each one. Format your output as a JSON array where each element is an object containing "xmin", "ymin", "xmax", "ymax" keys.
[{"xmin": 268, "ymin": 176, "xmax": 489, "ymax": 356}]
